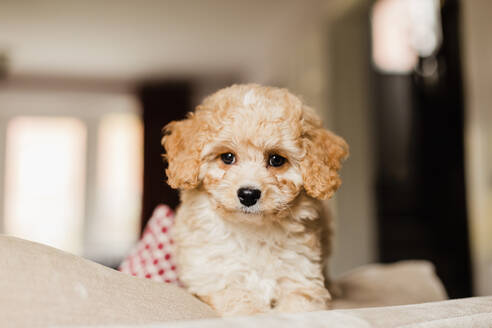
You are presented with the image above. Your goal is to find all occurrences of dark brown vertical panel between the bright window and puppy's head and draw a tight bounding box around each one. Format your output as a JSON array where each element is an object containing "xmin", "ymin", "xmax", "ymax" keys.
[{"xmin": 139, "ymin": 81, "xmax": 192, "ymax": 232}]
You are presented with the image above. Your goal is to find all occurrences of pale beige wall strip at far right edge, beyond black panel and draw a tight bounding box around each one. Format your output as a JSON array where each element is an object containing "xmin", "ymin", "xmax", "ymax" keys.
[{"xmin": 461, "ymin": 0, "xmax": 492, "ymax": 295}]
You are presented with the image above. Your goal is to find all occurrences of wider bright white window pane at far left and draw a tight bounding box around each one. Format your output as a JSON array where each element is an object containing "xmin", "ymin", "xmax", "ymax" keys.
[{"xmin": 4, "ymin": 116, "xmax": 87, "ymax": 254}]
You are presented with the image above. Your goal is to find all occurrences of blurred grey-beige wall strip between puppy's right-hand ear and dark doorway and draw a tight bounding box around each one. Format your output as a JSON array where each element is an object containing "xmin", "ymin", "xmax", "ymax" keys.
[{"xmin": 328, "ymin": 0, "xmax": 377, "ymax": 274}]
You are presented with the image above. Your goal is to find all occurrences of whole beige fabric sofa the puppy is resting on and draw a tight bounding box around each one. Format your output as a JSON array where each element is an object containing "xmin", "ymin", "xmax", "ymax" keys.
[{"xmin": 0, "ymin": 236, "xmax": 492, "ymax": 328}]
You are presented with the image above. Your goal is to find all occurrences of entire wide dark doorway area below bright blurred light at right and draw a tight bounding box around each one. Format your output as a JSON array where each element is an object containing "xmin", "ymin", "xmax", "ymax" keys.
[{"xmin": 374, "ymin": 0, "xmax": 471, "ymax": 297}]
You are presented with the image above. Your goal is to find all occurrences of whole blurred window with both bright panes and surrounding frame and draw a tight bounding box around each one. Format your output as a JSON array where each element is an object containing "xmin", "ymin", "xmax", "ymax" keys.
[{"xmin": 0, "ymin": 90, "xmax": 143, "ymax": 265}]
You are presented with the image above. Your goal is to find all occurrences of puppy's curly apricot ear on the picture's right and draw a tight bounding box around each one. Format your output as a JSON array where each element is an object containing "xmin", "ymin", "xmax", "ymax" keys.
[{"xmin": 301, "ymin": 127, "xmax": 348, "ymax": 199}]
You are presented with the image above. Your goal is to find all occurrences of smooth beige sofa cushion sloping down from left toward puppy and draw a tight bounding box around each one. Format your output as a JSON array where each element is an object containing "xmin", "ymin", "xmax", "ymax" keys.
[{"xmin": 0, "ymin": 236, "xmax": 217, "ymax": 327}]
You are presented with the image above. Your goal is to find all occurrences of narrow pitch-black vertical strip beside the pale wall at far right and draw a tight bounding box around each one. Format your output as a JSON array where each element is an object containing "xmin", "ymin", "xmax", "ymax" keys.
[{"xmin": 415, "ymin": 0, "xmax": 471, "ymax": 297}]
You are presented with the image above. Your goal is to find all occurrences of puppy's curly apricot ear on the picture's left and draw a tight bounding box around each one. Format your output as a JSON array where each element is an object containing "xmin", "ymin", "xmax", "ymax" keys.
[{"xmin": 162, "ymin": 113, "xmax": 202, "ymax": 189}]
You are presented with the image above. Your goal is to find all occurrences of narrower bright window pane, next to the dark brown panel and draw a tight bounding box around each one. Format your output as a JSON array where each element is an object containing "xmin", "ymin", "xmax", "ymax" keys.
[{"xmin": 88, "ymin": 113, "xmax": 143, "ymax": 261}]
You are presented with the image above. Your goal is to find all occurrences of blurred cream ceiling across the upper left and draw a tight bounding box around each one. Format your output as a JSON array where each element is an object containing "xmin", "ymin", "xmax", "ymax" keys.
[{"xmin": 0, "ymin": 0, "xmax": 330, "ymax": 80}]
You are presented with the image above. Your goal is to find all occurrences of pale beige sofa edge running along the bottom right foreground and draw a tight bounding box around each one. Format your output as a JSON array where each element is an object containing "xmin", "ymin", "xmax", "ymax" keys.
[{"xmin": 124, "ymin": 296, "xmax": 492, "ymax": 328}]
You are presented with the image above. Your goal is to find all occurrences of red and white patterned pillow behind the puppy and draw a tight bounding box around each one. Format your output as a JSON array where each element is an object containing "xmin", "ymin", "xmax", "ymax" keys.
[{"xmin": 119, "ymin": 205, "xmax": 180, "ymax": 285}]
